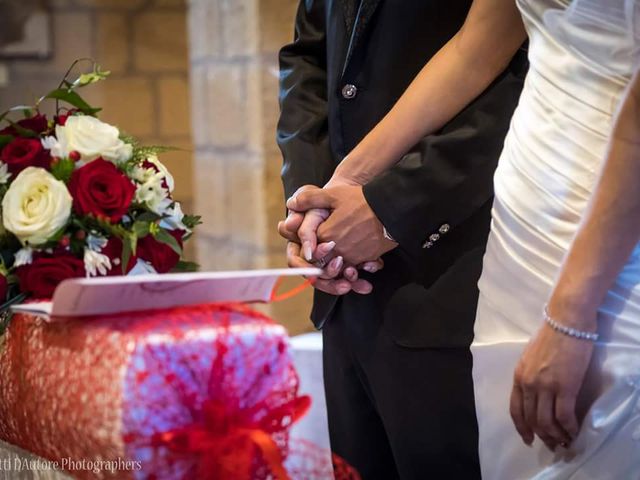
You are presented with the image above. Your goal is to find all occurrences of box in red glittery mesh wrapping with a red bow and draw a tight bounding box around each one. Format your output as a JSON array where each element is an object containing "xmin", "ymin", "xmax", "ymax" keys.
[{"xmin": 0, "ymin": 305, "xmax": 336, "ymax": 480}]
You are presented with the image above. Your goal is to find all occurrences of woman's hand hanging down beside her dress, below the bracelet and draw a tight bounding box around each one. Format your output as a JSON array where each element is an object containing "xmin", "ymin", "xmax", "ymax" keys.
[{"xmin": 510, "ymin": 310, "xmax": 596, "ymax": 451}]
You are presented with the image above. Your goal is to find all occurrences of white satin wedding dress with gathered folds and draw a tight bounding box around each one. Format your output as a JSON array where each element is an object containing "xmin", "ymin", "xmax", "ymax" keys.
[{"xmin": 472, "ymin": 0, "xmax": 640, "ymax": 480}]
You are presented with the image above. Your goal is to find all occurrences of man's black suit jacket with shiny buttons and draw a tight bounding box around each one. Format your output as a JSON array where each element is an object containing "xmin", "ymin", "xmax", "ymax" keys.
[{"xmin": 278, "ymin": 0, "xmax": 526, "ymax": 347}]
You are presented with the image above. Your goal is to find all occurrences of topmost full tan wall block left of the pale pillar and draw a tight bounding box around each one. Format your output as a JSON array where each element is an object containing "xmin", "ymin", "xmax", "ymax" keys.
[{"xmin": 133, "ymin": 11, "xmax": 188, "ymax": 72}]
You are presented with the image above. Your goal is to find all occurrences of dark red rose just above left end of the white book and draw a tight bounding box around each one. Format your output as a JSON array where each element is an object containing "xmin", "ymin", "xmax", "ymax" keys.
[{"xmin": 16, "ymin": 253, "xmax": 85, "ymax": 298}]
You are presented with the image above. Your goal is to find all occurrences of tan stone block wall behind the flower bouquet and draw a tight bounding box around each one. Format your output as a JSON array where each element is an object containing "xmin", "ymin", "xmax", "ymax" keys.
[{"xmin": 0, "ymin": 0, "xmax": 193, "ymax": 244}]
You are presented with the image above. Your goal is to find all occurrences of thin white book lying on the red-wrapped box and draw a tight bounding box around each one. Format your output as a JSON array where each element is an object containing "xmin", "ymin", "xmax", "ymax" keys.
[{"xmin": 11, "ymin": 268, "xmax": 322, "ymax": 319}]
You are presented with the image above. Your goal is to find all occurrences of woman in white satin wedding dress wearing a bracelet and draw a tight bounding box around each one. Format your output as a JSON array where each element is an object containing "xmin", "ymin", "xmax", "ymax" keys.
[{"xmin": 288, "ymin": 0, "xmax": 640, "ymax": 480}]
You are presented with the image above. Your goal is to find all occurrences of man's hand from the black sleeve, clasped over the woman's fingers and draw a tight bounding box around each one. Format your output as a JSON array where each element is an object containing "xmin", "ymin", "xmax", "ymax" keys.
[{"xmin": 287, "ymin": 186, "xmax": 398, "ymax": 265}]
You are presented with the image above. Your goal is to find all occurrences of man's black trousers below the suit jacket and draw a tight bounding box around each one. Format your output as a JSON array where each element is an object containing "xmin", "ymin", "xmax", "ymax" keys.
[{"xmin": 323, "ymin": 294, "xmax": 480, "ymax": 480}]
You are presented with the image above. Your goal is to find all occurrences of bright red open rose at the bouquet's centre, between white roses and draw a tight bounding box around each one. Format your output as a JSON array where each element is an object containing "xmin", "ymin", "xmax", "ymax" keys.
[{"xmin": 69, "ymin": 158, "xmax": 136, "ymax": 222}]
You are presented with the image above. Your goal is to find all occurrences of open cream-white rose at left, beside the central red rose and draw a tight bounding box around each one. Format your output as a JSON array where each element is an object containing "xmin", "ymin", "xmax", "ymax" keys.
[{"xmin": 2, "ymin": 167, "xmax": 73, "ymax": 245}]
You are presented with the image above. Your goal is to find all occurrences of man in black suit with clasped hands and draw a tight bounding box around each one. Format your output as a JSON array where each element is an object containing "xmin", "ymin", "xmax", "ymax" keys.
[{"xmin": 278, "ymin": 0, "xmax": 526, "ymax": 480}]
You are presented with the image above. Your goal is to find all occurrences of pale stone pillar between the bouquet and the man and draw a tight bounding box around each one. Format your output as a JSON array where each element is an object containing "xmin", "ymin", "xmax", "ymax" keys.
[{"xmin": 189, "ymin": 0, "xmax": 311, "ymax": 334}]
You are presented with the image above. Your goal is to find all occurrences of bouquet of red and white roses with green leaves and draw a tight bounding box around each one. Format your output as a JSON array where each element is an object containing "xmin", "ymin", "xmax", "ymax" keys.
[{"xmin": 0, "ymin": 65, "xmax": 199, "ymax": 309}]
